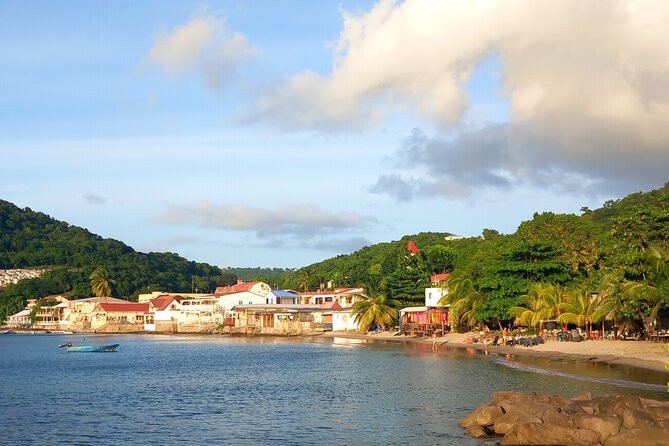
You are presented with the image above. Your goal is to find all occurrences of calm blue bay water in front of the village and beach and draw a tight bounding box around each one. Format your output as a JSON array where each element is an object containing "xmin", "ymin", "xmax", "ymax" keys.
[{"xmin": 0, "ymin": 335, "xmax": 668, "ymax": 445}]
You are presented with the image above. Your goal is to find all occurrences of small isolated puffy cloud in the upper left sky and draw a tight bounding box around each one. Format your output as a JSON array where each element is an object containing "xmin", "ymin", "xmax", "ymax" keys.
[{"xmin": 148, "ymin": 17, "xmax": 258, "ymax": 90}]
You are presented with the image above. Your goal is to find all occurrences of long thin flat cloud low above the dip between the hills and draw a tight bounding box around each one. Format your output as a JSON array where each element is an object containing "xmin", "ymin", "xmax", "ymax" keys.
[{"xmin": 157, "ymin": 201, "xmax": 375, "ymax": 237}]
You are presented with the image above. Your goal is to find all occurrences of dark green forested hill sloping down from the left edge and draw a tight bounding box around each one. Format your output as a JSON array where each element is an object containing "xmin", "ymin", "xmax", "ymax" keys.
[{"xmin": 0, "ymin": 200, "xmax": 236, "ymax": 321}]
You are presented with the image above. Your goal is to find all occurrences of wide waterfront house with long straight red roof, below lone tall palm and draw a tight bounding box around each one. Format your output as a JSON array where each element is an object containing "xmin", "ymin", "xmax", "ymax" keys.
[{"xmin": 91, "ymin": 302, "xmax": 149, "ymax": 333}]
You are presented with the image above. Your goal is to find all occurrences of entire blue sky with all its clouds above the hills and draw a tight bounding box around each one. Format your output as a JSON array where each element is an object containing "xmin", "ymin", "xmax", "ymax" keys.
[{"xmin": 0, "ymin": 0, "xmax": 669, "ymax": 268}]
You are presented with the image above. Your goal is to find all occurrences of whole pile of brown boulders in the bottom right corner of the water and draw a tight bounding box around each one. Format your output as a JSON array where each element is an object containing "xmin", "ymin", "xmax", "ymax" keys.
[{"xmin": 460, "ymin": 392, "xmax": 669, "ymax": 446}]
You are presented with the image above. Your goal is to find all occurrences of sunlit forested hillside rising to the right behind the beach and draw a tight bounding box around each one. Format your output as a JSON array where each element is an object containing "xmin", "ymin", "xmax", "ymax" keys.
[{"xmin": 280, "ymin": 185, "xmax": 669, "ymax": 324}]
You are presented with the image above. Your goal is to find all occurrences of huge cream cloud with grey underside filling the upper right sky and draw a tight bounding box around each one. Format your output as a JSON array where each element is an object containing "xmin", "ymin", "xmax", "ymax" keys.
[{"xmin": 258, "ymin": 0, "xmax": 669, "ymax": 200}]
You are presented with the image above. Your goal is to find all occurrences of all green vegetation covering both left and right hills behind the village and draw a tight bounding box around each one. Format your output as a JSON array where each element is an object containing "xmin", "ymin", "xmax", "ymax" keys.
[{"xmin": 0, "ymin": 180, "xmax": 669, "ymax": 331}]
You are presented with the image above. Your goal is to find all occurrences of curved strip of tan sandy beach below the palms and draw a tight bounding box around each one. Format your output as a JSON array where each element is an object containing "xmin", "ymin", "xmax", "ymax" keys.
[{"xmin": 323, "ymin": 332, "xmax": 669, "ymax": 375}]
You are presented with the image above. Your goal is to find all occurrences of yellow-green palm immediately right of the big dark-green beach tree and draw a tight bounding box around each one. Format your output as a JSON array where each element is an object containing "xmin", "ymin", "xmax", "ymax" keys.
[{"xmin": 509, "ymin": 284, "xmax": 568, "ymax": 327}]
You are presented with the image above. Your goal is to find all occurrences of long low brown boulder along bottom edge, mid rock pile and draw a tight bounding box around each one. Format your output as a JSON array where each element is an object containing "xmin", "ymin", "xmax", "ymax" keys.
[{"xmin": 499, "ymin": 424, "xmax": 599, "ymax": 446}]
